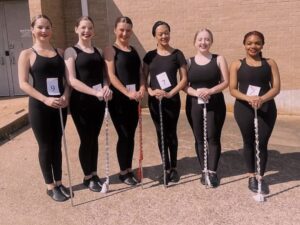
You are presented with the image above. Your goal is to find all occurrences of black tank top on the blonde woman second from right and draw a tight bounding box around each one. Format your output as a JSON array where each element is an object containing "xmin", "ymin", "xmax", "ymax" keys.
[{"xmin": 188, "ymin": 54, "xmax": 221, "ymax": 89}]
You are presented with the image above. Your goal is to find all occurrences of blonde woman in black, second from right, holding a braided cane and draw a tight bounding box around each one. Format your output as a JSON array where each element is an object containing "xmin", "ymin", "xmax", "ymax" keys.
[{"xmin": 185, "ymin": 29, "xmax": 229, "ymax": 187}]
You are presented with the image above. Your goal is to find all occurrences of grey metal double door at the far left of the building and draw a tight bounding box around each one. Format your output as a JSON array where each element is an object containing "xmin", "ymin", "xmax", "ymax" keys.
[{"xmin": 0, "ymin": 0, "xmax": 32, "ymax": 96}]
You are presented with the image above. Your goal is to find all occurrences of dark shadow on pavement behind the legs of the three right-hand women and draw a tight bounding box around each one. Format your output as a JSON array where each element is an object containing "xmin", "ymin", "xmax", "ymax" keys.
[{"xmin": 141, "ymin": 150, "xmax": 300, "ymax": 185}]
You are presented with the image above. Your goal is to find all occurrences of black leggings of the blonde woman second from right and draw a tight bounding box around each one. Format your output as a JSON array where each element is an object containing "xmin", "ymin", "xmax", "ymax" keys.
[{"xmin": 186, "ymin": 94, "xmax": 226, "ymax": 171}]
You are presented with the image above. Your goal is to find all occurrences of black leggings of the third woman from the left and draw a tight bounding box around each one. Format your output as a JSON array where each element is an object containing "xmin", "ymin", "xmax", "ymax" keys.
[{"xmin": 109, "ymin": 94, "xmax": 139, "ymax": 171}]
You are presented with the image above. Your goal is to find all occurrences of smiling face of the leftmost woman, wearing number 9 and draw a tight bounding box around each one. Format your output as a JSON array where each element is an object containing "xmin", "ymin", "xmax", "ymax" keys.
[{"xmin": 31, "ymin": 18, "xmax": 52, "ymax": 42}]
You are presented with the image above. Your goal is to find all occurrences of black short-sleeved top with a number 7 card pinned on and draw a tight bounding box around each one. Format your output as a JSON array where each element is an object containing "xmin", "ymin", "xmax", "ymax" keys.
[{"xmin": 144, "ymin": 49, "xmax": 186, "ymax": 91}]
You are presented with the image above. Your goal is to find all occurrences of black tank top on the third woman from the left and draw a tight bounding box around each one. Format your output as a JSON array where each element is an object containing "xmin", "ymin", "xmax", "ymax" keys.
[{"xmin": 113, "ymin": 46, "xmax": 141, "ymax": 92}]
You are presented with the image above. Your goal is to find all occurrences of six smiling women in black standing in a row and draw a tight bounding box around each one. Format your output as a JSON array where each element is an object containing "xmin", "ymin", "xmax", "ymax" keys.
[{"xmin": 18, "ymin": 15, "xmax": 280, "ymax": 201}]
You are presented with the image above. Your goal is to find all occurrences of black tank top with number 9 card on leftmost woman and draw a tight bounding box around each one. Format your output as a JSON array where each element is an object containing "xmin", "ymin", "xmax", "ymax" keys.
[{"xmin": 29, "ymin": 48, "xmax": 65, "ymax": 97}]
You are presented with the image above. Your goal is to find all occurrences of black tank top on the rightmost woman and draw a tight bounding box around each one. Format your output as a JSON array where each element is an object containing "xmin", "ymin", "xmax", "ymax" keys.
[{"xmin": 237, "ymin": 58, "xmax": 272, "ymax": 96}]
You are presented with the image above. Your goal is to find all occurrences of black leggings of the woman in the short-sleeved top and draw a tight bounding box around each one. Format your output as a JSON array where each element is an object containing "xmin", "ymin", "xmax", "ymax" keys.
[{"xmin": 148, "ymin": 94, "xmax": 181, "ymax": 170}]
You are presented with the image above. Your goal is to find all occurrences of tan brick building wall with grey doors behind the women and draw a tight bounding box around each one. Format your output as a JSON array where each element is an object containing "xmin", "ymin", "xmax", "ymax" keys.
[{"xmin": 0, "ymin": 0, "xmax": 300, "ymax": 115}]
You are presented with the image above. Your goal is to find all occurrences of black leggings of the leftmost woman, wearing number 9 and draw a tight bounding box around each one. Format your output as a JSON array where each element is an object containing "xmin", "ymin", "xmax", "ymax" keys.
[{"xmin": 29, "ymin": 98, "xmax": 67, "ymax": 184}]
